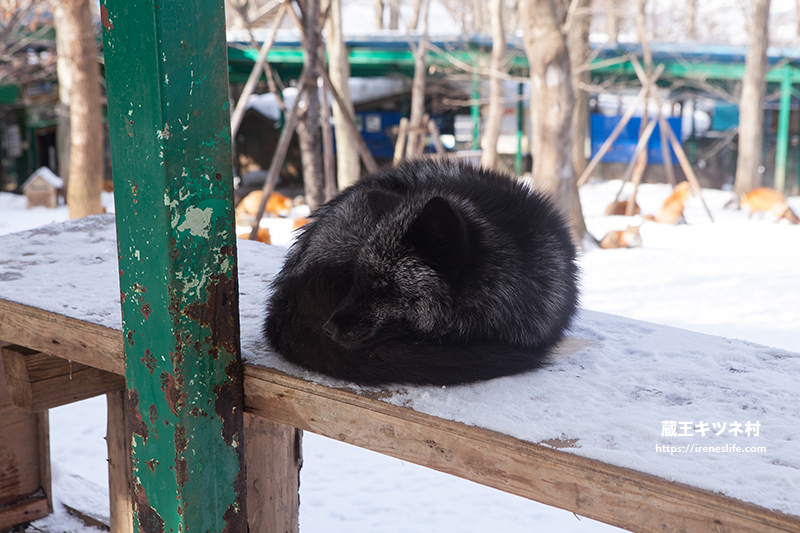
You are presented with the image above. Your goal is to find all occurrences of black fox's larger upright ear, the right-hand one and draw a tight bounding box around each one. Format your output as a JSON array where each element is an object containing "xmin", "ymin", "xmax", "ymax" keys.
[{"xmin": 405, "ymin": 196, "xmax": 467, "ymax": 271}]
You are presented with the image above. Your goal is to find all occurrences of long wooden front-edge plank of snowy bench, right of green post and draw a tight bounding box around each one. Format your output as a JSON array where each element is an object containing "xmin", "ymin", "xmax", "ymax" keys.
[{"xmin": 0, "ymin": 300, "xmax": 800, "ymax": 533}]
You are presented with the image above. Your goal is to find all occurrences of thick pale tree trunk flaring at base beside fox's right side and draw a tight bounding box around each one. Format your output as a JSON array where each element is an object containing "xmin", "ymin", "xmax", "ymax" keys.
[{"xmin": 520, "ymin": 0, "xmax": 586, "ymax": 245}]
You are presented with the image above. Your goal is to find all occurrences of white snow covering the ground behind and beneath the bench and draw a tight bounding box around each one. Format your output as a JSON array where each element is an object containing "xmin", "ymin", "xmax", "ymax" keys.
[{"xmin": 0, "ymin": 182, "xmax": 800, "ymax": 532}]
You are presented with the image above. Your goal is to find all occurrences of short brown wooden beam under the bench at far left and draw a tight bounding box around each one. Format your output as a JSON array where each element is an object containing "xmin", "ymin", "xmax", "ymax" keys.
[{"xmin": 0, "ymin": 345, "xmax": 125, "ymax": 411}]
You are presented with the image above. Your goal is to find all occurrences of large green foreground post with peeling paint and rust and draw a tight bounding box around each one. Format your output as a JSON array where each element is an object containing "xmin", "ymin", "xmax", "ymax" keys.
[{"xmin": 101, "ymin": 0, "xmax": 247, "ymax": 533}]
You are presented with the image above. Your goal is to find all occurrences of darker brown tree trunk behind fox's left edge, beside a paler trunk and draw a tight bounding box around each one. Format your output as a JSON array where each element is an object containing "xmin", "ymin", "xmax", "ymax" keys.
[{"xmin": 297, "ymin": 0, "xmax": 325, "ymax": 211}]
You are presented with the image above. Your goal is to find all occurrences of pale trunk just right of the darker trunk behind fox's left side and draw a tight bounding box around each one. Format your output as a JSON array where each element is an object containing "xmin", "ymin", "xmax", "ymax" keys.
[{"xmin": 326, "ymin": 0, "xmax": 361, "ymax": 190}]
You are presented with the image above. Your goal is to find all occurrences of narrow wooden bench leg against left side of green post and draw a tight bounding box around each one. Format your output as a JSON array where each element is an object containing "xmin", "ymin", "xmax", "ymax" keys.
[{"xmin": 106, "ymin": 390, "xmax": 133, "ymax": 533}]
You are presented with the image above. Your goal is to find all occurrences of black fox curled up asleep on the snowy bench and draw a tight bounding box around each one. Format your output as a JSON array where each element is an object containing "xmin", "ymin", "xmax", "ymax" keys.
[{"xmin": 265, "ymin": 161, "xmax": 578, "ymax": 385}]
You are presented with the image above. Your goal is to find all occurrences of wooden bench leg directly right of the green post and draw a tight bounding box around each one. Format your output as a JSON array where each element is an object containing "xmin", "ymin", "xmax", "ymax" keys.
[{"xmin": 244, "ymin": 413, "xmax": 303, "ymax": 533}]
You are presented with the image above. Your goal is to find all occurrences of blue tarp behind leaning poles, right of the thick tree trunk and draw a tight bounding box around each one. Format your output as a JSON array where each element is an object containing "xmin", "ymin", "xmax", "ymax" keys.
[{"xmin": 591, "ymin": 114, "xmax": 681, "ymax": 165}]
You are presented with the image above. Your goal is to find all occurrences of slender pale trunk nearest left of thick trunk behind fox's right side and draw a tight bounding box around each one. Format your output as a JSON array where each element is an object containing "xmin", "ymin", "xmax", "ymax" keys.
[{"xmin": 481, "ymin": 0, "xmax": 506, "ymax": 168}]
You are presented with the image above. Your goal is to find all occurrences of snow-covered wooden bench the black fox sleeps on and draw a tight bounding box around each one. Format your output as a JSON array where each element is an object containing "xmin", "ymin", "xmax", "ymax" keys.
[{"xmin": 0, "ymin": 215, "xmax": 800, "ymax": 532}]
